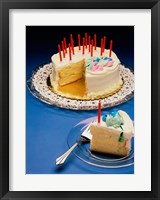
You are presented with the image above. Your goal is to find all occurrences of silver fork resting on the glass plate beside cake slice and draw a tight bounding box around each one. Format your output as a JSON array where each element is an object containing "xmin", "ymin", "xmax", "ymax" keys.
[{"xmin": 56, "ymin": 121, "xmax": 93, "ymax": 166}]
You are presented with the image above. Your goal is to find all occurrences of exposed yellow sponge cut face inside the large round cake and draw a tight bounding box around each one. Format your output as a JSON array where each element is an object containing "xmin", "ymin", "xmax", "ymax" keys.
[{"xmin": 58, "ymin": 59, "xmax": 85, "ymax": 86}]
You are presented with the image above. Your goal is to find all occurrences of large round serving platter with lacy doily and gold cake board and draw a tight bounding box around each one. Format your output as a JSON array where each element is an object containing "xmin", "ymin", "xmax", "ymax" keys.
[{"xmin": 27, "ymin": 63, "xmax": 134, "ymax": 110}]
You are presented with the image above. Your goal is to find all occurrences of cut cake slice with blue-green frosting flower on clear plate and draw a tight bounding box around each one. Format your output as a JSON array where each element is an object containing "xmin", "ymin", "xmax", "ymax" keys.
[{"xmin": 90, "ymin": 110, "xmax": 134, "ymax": 156}]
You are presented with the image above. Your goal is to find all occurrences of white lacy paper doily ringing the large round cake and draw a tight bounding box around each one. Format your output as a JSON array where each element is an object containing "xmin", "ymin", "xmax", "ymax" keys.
[{"xmin": 27, "ymin": 63, "xmax": 134, "ymax": 110}]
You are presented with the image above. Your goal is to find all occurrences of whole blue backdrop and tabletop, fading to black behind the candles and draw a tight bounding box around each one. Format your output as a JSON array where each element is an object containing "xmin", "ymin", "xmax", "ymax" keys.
[{"xmin": 26, "ymin": 26, "xmax": 134, "ymax": 174}]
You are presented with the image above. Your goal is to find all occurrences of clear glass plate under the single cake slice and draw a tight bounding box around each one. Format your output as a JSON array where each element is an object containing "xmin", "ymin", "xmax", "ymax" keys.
[{"xmin": 67, "ymin": 117, "xmax": 134, "ymax": 168}]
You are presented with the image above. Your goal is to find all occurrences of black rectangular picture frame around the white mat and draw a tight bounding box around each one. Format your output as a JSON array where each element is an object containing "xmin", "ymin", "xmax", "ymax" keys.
[{"xmin": 0, "ymin": 0, "xmax": 160, "ymax": 200}]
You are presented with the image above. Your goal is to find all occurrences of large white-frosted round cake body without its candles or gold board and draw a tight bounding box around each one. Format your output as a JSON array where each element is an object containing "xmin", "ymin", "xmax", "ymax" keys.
[{"xmin": 50, "ymin": 46, "xmax": 123, "ymax": 99}]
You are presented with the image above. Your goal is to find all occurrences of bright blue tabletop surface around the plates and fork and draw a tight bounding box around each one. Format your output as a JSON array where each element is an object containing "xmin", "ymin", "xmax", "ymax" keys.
[{"xmin": 26, "ymin": 83, "xmax": 134, "ymax": 174}]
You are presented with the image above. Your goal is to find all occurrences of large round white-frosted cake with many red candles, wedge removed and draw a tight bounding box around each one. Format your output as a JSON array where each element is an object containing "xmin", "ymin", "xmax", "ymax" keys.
[{"xmin": 50, "ymin": 36, "xmax": 123, "ymax": 99}]
